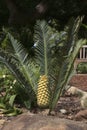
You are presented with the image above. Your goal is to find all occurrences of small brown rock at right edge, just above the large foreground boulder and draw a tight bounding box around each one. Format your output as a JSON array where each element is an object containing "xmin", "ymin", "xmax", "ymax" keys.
[{"xmin": 75, "ymin": 110, "xmax": 87, "ymax": 121}]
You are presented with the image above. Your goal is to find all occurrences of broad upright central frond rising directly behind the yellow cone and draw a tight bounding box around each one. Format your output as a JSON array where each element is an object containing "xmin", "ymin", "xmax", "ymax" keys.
[{"xmin": 34, "ymin": 21, "xmax": 60, "ymax": 93}]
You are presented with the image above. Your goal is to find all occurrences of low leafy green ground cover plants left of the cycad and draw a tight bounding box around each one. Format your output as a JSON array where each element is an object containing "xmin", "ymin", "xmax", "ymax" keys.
[{"xmin": 0, "ymin": 64, "xmax": 21, "ymax": 116}]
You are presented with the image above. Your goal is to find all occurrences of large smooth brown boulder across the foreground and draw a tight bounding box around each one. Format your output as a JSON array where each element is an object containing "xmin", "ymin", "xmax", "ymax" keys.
[{"xmin": 2, "ymin": 112, "xmax": 87, "ymax": 130}]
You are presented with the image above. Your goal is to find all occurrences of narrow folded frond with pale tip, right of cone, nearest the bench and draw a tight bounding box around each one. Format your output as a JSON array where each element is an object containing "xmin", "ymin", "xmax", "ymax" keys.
[{"xmin": 51, "ymin": 40, "xmax": 86, "ymax": 109}]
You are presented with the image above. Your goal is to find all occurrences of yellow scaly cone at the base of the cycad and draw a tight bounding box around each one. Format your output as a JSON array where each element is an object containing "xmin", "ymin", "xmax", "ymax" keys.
[{"xmin": 37, "ymin": 75, "xmax": 51, "ymax": 108}]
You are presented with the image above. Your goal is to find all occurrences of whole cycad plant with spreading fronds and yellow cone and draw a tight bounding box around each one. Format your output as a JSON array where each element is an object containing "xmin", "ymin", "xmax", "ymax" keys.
[{"xmin": 0, "ymin": 17, "xmax": 86, "ymax": 114}]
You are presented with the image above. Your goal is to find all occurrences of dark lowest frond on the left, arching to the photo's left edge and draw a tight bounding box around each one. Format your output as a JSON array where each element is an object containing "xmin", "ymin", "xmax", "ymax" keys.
[{"xmin": 0, "ymin": 49, "xmax": 32, "ymax": 93}]
